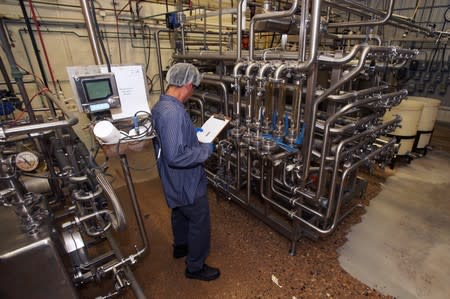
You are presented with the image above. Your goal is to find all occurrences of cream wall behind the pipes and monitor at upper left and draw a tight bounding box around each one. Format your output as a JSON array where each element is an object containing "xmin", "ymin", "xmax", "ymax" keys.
[{"xmin": 0, "ymin": 0, "xmax": 236, "ymax": 141}]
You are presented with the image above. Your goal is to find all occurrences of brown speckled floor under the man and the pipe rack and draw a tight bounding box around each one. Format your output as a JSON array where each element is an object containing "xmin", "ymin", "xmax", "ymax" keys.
[{"xmin": 82, "ymin": 122, "xmax": 450, "ymax": 299}]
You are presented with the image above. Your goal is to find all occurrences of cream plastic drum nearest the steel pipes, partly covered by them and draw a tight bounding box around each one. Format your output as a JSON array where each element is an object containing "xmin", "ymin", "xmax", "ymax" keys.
[{"xmin": 383, "ymin": 100, "xmax": 423, "ymax": 155}]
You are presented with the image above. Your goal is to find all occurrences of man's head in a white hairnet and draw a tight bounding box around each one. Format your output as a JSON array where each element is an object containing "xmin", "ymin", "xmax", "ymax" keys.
[{"xmin": 166, "ymin": 63, "xmax": 202, "ymax": 102}]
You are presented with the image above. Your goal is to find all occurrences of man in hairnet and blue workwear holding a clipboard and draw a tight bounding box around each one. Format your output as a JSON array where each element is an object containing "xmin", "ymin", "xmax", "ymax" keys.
[{"xmin": 152, "ymin": 63, "xmax": 220, "ymax": 281}]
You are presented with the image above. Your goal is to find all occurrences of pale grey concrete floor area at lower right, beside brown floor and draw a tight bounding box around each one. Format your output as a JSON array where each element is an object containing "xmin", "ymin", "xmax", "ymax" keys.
[{"xmin": 339, "ymin": 127, "xmax": 450, "ymax": 298}]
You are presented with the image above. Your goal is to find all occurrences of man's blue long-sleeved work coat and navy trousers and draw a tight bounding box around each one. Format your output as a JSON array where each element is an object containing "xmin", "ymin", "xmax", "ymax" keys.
[{"xmin": 152, "ymin": 95, "xmax": 212, "ymax": 272}]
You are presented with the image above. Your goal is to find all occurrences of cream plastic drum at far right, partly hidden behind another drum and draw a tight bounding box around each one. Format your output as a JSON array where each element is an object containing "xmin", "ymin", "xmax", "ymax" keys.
[{"xmin": 408, "ymin": 97, "xmax": 441, "ymax": 151}]
